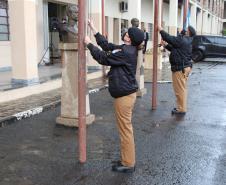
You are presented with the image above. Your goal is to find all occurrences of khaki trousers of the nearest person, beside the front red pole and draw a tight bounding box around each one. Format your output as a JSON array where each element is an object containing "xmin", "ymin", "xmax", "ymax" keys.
[{"xmin": 114, "ymin": 93, "xmax": 136, "ymax": 167}]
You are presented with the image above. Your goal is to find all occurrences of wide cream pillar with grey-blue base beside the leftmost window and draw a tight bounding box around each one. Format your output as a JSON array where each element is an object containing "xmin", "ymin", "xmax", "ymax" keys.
[{"xmin": 8, "ymin": 0, "xmax": 39, "ymax": 85}]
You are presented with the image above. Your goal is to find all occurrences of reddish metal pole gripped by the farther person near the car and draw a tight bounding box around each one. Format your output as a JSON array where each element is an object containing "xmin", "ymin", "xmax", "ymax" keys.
[{"xmin": 152, "ymin": 0, "xmax": 159, "ymax": 110}]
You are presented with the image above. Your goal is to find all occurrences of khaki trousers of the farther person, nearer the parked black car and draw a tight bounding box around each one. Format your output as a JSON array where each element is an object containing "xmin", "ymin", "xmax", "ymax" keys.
[{"xmin": 172, "ymin": 67, "xmax": 191, "ymax": 112}]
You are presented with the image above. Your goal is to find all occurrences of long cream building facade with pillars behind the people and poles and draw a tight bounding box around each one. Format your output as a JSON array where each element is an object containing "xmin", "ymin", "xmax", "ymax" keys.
[{"xmin": 0, "ymin": 0, "xmax": 224, "ymax": 84}]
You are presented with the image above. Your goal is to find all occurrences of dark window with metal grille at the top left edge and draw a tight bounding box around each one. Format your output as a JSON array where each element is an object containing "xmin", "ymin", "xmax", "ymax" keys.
[{"xmin": 0, "ymin": 0, "xmax": 9, "ymax": 41}]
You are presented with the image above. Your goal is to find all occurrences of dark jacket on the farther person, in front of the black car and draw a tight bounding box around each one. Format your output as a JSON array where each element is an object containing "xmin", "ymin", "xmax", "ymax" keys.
[{"xmin": 160, "ymin": 31, "xmax": 193, "ymax": 72}]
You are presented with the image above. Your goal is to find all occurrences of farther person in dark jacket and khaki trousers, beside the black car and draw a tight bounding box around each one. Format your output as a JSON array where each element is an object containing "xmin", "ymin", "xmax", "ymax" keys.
[{"xmin": 159, "ymin": 26, "xmax": 196, "ymax": 115}]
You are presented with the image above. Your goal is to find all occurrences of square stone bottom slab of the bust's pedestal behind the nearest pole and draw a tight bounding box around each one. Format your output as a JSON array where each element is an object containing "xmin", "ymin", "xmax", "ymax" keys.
[{"xmin": 56, "ymin": 114, "xmax": 95, "ymax": 128}]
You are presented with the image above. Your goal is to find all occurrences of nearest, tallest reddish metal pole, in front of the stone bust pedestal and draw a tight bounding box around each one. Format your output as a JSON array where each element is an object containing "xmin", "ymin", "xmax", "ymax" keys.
[{"xmin": 78, "ymin": 0, "xmax": 86, "ymax": 163}]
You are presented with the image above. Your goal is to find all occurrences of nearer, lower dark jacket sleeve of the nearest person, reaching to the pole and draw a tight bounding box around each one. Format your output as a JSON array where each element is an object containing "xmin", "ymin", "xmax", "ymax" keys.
[{"xmin": 87, "ymin": 44, "xmax": 126, "ymax": 66}]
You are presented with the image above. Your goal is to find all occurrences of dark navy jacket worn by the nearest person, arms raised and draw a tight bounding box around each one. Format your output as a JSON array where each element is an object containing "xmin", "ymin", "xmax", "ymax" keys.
[{"xmin": 87, "ymin": 33, "xmax": 138, "ymax": 98}]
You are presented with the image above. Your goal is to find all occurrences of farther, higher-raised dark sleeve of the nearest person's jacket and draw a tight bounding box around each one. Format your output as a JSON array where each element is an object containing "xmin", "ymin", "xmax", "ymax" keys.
[{"xmin": 94, "ymin": 32, "xmax": 120, "ymax": 51}]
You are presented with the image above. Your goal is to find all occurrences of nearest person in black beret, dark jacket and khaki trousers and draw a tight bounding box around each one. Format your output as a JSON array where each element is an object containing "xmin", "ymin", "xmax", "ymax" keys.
[{"xmin": 85, "ymin": 21, "xmax": 144, "ymax": 173}]
